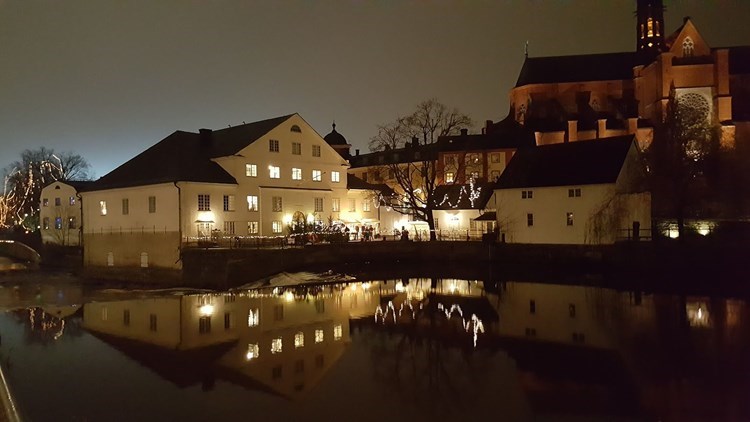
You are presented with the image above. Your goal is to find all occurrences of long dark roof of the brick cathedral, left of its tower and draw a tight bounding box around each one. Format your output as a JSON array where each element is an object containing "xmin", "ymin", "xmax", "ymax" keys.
[{"xmin": 516, "ymin": 52, "xmax": 640, "ymax": 87}]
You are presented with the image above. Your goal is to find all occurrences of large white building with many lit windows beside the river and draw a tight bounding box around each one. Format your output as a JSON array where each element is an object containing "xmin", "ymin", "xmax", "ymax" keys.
[{"xmin": 82, "ymin": 114, "xmax": 348, "ymax": 268}]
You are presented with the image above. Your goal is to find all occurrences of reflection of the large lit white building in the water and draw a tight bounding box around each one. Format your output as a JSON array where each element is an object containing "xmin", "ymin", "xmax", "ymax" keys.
[{"xmin": 84, "ymin": 283, "xmax": 373, "ymax": 397}]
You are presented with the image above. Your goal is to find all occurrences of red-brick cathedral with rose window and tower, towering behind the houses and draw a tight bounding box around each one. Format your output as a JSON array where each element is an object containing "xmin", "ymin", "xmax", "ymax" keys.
[{"xmin": 509, "ymin": 0, "xmax": 750, "ymax": 149}]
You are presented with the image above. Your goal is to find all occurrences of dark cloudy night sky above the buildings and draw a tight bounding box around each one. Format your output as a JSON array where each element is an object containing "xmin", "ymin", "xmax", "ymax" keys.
[{"xmin": 0, "ymin": 0, "xmax": 750, "ymax": 177}]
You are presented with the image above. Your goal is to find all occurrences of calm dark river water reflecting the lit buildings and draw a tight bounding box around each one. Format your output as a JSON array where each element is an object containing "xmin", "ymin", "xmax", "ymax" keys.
[{"xmin": 0, "ymin": 274, "xmax": 750, "ymax": 422}]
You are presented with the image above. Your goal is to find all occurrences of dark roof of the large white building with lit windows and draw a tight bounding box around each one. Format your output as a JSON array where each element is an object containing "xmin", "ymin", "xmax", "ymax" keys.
[{"xmin": 88, "ymin": 115, "xmax": 292, "ymax": 190}]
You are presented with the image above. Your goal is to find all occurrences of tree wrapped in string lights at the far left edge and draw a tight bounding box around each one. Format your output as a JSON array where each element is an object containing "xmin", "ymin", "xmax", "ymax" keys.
[{"xmin": 0, "ymin": 147, "xmax": 90, "ymax": 230}]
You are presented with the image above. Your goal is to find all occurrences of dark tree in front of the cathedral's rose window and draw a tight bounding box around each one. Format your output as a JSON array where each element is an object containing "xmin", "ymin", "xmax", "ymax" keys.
[{"xmin": 648, "ymin": 86, "xmax": 720, "ymax": 238}]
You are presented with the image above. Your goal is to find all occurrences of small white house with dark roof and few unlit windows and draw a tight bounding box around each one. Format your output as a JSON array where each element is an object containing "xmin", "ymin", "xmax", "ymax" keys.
[{"xmin": 490, "ymin": 135, "xmax": 651, "ymax": 244}]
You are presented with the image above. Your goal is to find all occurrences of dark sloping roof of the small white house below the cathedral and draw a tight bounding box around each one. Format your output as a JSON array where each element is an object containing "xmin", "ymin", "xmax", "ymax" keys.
[{"xmin": 495, "ymin": 135, "xmax": 634, "ymax": 189}]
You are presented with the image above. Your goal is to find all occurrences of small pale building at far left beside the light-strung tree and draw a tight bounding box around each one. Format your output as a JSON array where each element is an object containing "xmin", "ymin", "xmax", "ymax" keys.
[{"xmin": 39, "ymin": 180, "xmax": 92, "ymax": 246}]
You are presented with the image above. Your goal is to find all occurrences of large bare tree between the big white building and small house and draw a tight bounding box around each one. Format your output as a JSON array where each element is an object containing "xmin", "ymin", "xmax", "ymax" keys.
[{"xmin": 370, "ymin": 98, "xmax": 473, "ymax": 240}]
